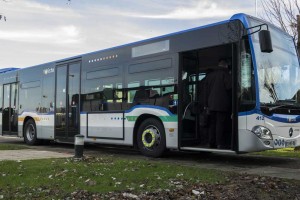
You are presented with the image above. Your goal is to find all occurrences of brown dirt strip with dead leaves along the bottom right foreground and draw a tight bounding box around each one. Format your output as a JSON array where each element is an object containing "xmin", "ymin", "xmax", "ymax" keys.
[{"xmin": 66, "ymin": 174, "xmax": 300, "ymax": 200}]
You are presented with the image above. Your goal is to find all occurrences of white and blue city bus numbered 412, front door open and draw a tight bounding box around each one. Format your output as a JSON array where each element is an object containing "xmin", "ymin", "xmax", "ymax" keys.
[{"xmin": 0, "ymin": 14, "xmax": 300, "ymax": 157}]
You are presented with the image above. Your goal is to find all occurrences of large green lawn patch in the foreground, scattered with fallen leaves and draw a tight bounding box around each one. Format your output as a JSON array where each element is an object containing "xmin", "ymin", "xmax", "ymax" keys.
[{"xmin": 0, "ymin": 156, "xmax": 225, "ymax": 199}]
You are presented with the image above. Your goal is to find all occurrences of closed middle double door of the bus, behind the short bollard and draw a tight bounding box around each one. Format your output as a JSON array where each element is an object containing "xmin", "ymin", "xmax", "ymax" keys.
[{"xmin": 55, "ymin": 62, "xmax": 80, "ymax": 139}]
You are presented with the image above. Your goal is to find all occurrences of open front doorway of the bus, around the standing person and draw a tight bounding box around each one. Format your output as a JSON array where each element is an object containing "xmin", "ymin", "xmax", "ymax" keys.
[{"xmin": 179, "ymin": 43, "xmax": 238, "ymax": 153}]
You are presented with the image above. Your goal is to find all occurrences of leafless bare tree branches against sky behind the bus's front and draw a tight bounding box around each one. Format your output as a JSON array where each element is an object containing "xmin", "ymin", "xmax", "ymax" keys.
[{"xmin": 261, "ymin": 0, "xmax": 300, "ymax": 48}]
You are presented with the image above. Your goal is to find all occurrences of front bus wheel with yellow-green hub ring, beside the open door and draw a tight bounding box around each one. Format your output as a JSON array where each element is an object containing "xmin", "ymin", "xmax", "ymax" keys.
[{"xmin": 137, "ymin": 118, "xmax": 166, "ymax": 158}]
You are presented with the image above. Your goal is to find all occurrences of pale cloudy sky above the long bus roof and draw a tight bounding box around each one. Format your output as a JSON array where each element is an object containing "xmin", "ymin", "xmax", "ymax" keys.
[{"xmin": 0, "ymin": 0, "xmax": 259, "ymax": 68}]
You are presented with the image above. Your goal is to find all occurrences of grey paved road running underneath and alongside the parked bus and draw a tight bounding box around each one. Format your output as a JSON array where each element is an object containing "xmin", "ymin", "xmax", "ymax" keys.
[{"xmin": 0, "ymin": 136, "xmax": 300, "ymax": 180}]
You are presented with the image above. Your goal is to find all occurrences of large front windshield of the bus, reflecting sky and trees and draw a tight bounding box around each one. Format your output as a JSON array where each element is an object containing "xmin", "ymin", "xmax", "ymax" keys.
[{"xmin": 249, "ymin": 18, "xmax": 300, "ymax": 106}]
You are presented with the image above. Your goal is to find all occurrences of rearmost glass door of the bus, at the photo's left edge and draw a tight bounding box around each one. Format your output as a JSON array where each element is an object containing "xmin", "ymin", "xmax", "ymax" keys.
[{"xmin": 2, "ymin": 83, "xmax": 19, "ymax": 135}]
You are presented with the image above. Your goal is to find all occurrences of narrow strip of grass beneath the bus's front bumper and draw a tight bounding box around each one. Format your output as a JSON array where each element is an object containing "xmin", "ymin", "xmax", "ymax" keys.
[{"xmin": 253, "ymin": 148, "xmax": 300, "ymax": 158}]
